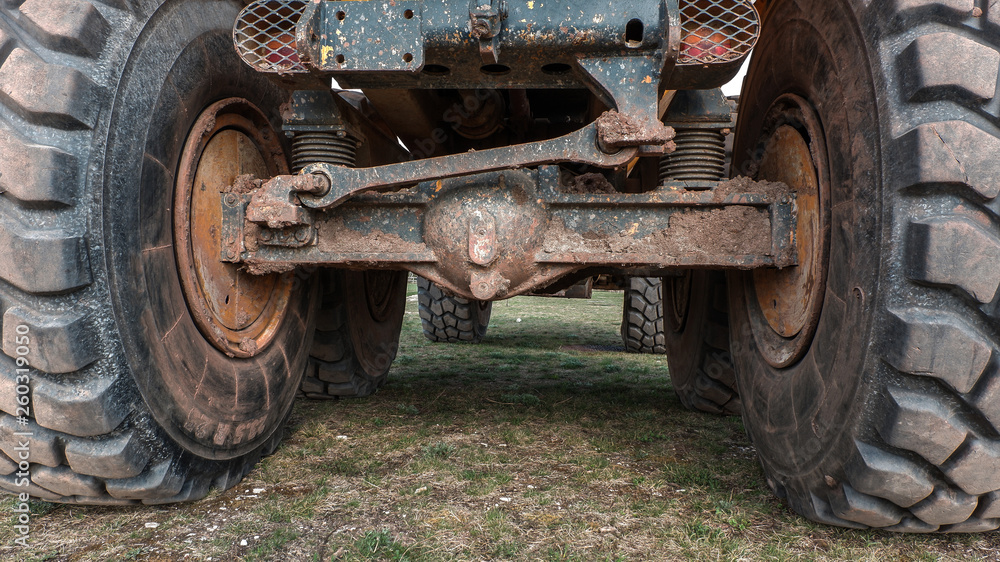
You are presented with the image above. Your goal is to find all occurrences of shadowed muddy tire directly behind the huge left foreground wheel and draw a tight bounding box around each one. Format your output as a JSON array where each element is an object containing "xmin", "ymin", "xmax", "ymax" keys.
[{"xmin": 302, "ymin": 270, "xmax": 407, "ymax": 399}]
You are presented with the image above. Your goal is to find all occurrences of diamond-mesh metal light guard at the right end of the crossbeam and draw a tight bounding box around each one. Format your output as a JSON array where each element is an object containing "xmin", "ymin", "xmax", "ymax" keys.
[{"xmin": 677, "ymin": 0, "xmax": 760, "ymax": 65}]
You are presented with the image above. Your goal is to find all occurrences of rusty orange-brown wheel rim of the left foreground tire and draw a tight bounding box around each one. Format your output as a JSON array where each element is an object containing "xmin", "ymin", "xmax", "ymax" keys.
[{"xmin": 174, "ymin": 98, "xmax": 294, "ymax": 357}]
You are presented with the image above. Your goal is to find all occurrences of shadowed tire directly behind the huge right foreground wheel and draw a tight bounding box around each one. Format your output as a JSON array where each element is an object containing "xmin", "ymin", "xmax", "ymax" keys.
[{"xmin": 663, "ymin": 270, "xmax": 741, "ymax": 415}]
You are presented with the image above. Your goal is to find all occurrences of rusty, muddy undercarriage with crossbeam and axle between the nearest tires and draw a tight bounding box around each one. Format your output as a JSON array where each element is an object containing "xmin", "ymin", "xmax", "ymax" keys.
[{"xmin": 221, "ymin": 1, "xmax": 797, "ymax": 301}]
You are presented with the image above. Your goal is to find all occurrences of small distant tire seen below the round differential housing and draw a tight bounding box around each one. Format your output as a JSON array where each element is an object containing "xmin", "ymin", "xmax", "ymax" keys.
[{"xmin": 417, "ymin": 277, "xmax": 493, "ymax": 343}]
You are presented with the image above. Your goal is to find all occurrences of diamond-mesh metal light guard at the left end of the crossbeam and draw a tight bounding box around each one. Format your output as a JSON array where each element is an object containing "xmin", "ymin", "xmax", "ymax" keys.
[{"xmin": 233, "ymin": 0, "xmax": 306, "ymax": 74}]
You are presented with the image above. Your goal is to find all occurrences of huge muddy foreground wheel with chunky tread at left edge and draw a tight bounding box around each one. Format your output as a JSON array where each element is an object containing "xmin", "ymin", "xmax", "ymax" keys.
[{"xmin": 0, "ymin": 0, "xmax": 316, "ymax": 504}]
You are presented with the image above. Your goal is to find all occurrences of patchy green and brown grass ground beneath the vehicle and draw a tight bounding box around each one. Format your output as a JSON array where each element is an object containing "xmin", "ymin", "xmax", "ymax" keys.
[{"xmin": 0, "ymin": 287, "xmax": 1000, "ymax": 561}]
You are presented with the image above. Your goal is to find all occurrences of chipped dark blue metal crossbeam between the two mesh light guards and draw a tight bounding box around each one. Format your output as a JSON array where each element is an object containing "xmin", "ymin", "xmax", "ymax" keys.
[{"xmin": 299, "ymin": 0, "xmax": 676, "ymax": 89}]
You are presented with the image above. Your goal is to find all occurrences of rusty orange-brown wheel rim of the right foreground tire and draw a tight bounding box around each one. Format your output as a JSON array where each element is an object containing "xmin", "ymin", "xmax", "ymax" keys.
[{"xmin": 748, "ymin": 95, "xmax": 829, "ymax": 368}]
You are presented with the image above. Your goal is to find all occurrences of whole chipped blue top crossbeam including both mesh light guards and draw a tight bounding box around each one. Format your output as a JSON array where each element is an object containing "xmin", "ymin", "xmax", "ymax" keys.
[{"xmin": 234, "ymin": 0, "xmax": 759, "ymax": 90}]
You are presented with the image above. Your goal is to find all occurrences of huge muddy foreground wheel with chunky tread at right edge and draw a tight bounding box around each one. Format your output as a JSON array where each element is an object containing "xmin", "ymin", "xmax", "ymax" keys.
[{"xmin": 730, "ymin": 0, "xmax": 1000, "ymax": 532}]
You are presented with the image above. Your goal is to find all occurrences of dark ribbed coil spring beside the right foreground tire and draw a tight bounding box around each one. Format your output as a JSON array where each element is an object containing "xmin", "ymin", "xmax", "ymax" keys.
[{"xmin": 660, "ymin": 129, "xmax": 726, "ymax": 183}]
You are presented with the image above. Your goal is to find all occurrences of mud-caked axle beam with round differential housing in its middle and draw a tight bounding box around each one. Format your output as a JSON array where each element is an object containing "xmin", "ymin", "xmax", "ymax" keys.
[{"xmin": 231, "ymin": 166, "xmax": 795, "ymax": 300}]
